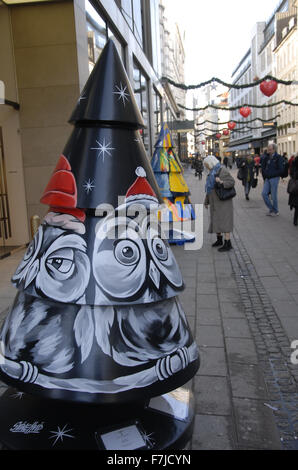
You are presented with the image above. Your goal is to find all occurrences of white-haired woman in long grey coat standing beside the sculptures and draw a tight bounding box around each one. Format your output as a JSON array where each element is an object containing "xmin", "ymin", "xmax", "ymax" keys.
[{"xmin": 204, "ymin": 155, "xmax": 235, "ymax": 251}]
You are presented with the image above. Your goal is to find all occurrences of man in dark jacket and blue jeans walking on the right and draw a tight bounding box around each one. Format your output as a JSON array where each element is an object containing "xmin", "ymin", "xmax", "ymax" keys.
[{"xmin": 261, "ymin": 144, "xmax": 283, "ymax": 217}]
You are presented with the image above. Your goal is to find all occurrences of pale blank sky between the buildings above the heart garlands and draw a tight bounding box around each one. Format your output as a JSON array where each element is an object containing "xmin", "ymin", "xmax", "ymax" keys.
[{"xmin": 165, "ymin": 0, "xmax": 279, "ymax": 85}]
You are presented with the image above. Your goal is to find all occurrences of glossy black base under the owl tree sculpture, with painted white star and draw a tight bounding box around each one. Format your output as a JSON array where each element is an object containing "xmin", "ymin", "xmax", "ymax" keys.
[{"xmin": 0, "ymin": 383, "xmax": 194, "ymax": 450}]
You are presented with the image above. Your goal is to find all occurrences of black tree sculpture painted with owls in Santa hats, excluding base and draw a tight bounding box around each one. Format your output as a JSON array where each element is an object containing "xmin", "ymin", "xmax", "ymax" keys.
[{"xmin": 0, "ymin": 41, "xmax": 199, "ymax": 450}]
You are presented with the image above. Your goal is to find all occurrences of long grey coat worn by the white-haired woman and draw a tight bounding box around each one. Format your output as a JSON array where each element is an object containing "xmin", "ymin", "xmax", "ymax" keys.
[{"xmin": 204, "ymin": 167, "xmax": 235, "ymax": 233}]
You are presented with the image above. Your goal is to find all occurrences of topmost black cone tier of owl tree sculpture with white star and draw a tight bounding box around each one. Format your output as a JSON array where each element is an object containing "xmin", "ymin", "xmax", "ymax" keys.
[{"xmin": 69, "ymin": 39, "xmax": 145, "ymax": 129}]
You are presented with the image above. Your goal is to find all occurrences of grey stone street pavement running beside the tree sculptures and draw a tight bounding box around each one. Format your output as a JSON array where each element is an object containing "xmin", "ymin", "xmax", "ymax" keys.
[{"xmin": 0, "ymin": 165, "xmax": 298, "ymax": 450}]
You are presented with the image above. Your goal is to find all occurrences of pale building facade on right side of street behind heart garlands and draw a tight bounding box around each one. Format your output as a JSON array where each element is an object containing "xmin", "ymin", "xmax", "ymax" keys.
[{"xmin": 229, "ymin": 0, "xmax": 297, "ymax": 156}]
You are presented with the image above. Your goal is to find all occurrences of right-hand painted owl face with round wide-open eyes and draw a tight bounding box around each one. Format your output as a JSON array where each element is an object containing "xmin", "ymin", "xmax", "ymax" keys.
[{"xmin": 92, "ymin": 216, "xmax": 183, "ymax": 305}]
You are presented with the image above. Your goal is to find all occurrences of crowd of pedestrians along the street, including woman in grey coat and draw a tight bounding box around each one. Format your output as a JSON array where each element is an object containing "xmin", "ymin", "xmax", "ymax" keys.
[{"xmin": 192, "ymin": 147, "xmax": 298, "ymax": 255}]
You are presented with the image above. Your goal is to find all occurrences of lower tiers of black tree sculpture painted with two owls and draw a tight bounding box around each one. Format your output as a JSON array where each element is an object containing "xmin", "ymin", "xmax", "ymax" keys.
[{"xmin": 0, "ymin": 170, "xmax": 198, "ymax": 403}]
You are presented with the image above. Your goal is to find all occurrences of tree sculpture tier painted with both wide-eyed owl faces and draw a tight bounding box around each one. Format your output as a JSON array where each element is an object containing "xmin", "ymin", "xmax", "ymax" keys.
[{"xmin": 12, "ymin": 207, "xmax": 183, "ymax": 305}]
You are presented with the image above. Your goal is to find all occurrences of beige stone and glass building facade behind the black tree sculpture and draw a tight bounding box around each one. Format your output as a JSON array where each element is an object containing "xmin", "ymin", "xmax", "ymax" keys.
[{"xmin": 0, "ymin": 0, "xmax": 185, "ymax": 250}]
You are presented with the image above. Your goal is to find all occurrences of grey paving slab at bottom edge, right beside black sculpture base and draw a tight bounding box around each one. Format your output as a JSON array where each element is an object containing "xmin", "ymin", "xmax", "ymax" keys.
[{"xmin": 192, "ymin": 414, "xmax": 235, "ymax": 450}]
